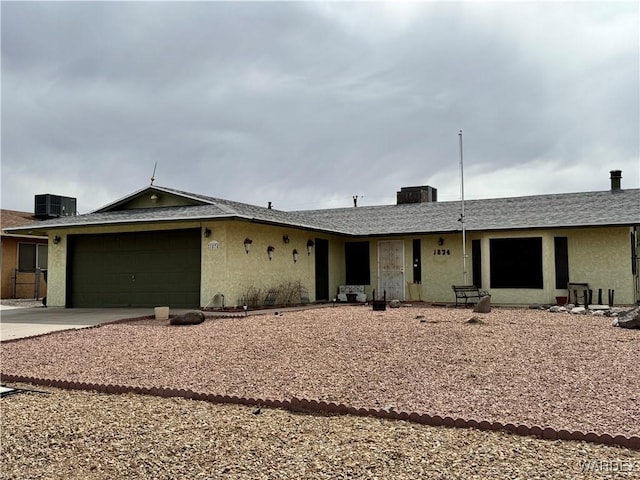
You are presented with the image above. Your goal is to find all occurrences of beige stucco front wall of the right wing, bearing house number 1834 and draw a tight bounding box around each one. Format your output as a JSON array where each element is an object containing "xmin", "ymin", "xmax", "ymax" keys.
[{"xmin": 344, "ymin": 227, "xmax": 636, "ymax": 305}]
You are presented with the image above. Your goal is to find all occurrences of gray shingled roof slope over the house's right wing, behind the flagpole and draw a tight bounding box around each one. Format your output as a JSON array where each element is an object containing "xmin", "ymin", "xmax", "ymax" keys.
[{"xmin": 298, "ymin": 189, "xmax": 640, "ymax": 235}]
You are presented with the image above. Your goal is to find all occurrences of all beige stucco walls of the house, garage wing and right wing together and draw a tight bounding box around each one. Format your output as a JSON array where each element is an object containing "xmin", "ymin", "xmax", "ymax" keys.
[{"xmin": 42, "ymin": 221, "xmax": 636, "ymax": 307}]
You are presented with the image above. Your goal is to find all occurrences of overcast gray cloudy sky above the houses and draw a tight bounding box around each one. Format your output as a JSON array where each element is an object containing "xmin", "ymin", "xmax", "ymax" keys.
[{"xmin": 1, "ymin": 1, "xmax": 640, "ymax": 213}]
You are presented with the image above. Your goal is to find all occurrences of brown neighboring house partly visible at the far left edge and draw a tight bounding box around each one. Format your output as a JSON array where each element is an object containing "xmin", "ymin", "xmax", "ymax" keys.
[{"xmin": 0, "ymin": 209, "xmax": 48, "ymax": 298}]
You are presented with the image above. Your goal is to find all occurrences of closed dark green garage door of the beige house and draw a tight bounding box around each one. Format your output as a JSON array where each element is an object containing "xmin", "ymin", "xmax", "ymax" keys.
[{"xmin": 67, "ymin": 229, "xmax": 200, "ymax": 308}]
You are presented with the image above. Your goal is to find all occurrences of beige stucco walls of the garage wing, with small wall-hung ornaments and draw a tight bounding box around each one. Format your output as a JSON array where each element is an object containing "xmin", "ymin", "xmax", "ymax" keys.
[{"xmin": 47, "ymin": 221, "xmax": 324, "ymax": 307}]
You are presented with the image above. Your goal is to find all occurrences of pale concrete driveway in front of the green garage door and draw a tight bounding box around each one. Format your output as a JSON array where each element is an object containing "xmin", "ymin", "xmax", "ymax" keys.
[{"xmin": 0, "ymin": 305, "xmax": 180, "ymax": 341}]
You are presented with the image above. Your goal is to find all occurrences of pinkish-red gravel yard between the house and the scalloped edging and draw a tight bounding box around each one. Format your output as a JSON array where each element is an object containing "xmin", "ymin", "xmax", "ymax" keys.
[{"xmin": 0, "ymin": 306, "xmax": 640, "ymax": 436}]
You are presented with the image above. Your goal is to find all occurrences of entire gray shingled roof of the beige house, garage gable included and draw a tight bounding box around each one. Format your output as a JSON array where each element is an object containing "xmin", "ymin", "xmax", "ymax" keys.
[{"xmin": 6, "ymin": 186, "xmax": 640, "ymax": 236}]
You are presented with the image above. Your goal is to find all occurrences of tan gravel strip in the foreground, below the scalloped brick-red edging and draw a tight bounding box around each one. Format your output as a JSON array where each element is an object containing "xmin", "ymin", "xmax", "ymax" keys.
[{"xmin": 0, "ymin": 385, "xmax": 640, "ymax": 480}]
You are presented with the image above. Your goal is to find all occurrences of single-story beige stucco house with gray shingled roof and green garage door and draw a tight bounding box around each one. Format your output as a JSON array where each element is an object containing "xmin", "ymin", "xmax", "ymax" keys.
[{"xmin": 6, "ymin": 171, "xmax": 640, "ymax": 308}]
